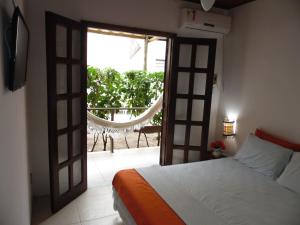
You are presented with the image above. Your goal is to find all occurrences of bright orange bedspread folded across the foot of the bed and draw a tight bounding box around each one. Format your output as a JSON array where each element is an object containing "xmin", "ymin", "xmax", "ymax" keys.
[{"xmin": 113, "ymin": 169, "xmax": 184, "ymax": 225}]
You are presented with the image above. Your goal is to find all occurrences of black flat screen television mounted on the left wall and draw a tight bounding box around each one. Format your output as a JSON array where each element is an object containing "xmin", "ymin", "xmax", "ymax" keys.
[{"xmin": 8, "ymin": 7, "xmax": 29, "ymax": 91}]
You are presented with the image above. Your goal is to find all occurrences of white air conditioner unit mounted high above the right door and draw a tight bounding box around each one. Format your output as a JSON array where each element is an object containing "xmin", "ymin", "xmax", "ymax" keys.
[{"xmin": 181, "ymin": 8, "xmax": 231, "ymax": 34}]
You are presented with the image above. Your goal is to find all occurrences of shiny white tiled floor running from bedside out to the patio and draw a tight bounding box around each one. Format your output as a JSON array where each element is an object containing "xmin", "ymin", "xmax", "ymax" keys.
[{"xmin": 32, "ymin": 147, "xmax": 159, "ymax": 225}]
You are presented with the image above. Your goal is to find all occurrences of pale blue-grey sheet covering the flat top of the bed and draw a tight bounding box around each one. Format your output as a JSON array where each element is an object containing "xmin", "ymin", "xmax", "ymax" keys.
[{"xmin": 113, "ymin": 158, "xmax": 300, "ymax": 225}]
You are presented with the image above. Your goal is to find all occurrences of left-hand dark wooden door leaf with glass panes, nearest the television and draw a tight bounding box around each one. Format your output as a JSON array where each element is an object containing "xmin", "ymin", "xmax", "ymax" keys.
[{"xmin": 46, "ymin": 12, "xmax": 87, "ymax": 212}]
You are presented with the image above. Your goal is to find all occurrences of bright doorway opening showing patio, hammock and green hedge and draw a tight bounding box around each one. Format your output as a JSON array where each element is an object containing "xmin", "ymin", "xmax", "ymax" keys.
[{"xmin": 87, "ymin": 26, "xmax": 167, "ymax": 188}]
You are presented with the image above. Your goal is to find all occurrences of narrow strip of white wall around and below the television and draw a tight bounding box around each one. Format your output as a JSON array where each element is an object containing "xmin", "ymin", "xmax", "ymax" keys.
[{"xmin": 0, "ymin": 0, "xmax": 31, "ymax": 225}]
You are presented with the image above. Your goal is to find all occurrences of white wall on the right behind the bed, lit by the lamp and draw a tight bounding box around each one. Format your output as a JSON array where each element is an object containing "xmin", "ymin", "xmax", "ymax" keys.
[{"xmin": 218, "ymin": 0, "xmax": 300, "ymax": 153}]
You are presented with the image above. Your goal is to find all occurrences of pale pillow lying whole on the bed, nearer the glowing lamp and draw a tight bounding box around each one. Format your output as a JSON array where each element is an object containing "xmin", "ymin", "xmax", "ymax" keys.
[{"xmin": 234, "ymin": 134, "xmax": 293, "ymax": 179}]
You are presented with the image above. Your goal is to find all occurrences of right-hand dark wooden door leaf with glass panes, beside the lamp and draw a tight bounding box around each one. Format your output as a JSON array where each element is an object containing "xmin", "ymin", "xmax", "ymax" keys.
[{"xmin": 160, "ymin": 37, "xmax": 216, "ymax": 165}]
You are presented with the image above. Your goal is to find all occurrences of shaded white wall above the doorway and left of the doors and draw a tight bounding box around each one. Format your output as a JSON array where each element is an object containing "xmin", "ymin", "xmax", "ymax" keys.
[{"xmin": 27, "ymin": 0, "xmax": 223, "ymax": 195}]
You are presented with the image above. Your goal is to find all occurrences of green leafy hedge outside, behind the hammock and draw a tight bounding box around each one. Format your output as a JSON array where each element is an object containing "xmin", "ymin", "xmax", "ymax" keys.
[{"xmin": 87, "ymin": 66, "xmax": 164, "ymax": 125}]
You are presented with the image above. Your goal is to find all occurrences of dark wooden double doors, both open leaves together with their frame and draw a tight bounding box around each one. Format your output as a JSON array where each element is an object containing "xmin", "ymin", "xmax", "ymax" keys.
[{"xmin": 46, "ymin": 12, "xmax": 216, "ymax": 213}]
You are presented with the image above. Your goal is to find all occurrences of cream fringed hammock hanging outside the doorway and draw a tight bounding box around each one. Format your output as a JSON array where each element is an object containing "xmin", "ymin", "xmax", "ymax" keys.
[{"xmin": 87, "ymin": 95, "xmax": 163, "ymax": 133}]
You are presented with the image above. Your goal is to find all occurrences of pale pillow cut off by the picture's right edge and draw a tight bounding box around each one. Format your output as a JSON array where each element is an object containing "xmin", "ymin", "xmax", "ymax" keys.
[{"xmin": 277, "ymin": 152, "xmax": 300, "ymax": 194}]
